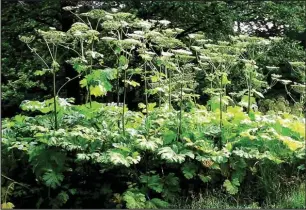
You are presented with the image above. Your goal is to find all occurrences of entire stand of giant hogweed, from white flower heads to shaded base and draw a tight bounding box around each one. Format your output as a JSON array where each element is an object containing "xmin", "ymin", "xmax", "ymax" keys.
[{"xmin": 1, "ymin": 6, "xmax": 305, "ymax": 209}]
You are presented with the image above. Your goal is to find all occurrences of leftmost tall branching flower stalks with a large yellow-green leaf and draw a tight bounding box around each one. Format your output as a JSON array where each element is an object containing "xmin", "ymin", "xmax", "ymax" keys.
[{"xmin": 20, "ymin": 10, "xmax": 114, "ymax": 129}]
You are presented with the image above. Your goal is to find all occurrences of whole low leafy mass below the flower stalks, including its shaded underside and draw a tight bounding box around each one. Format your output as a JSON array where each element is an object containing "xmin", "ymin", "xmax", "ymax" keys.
[{"xmin": 2, "ymin": 102, "xmax": 305, "ymax": 208}]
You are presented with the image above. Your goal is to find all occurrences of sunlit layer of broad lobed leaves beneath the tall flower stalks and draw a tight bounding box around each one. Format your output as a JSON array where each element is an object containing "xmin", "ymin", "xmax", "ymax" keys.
[{"xmin": 2, "ymin": 95, "xmax": 305, "ymax": 208}]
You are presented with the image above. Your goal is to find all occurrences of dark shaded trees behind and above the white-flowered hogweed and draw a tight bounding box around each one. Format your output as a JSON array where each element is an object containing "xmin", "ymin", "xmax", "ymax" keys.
[{"xmin": 1, "ymin": 0, "xmax": 306, "ymax": 117}]
